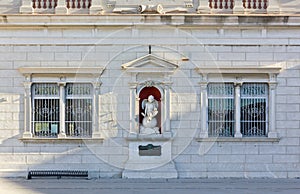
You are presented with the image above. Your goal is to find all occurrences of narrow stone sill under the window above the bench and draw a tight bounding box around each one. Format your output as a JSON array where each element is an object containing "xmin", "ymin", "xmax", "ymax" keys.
[{"xmin": 19, "ymin": 138, "xmax": 104, "ymax": 144}]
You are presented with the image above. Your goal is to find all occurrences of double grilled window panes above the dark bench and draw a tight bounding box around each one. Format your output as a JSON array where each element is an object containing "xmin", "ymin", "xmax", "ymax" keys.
[{"xmin": 32, "ymin": 83, "xmax": 93, "ymax": 137}]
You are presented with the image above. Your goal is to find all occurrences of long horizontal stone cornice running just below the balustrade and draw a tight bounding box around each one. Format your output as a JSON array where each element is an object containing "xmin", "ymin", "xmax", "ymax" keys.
[{"xmin": 0, "ymin": 14, "xmax": 300, "ymax": 28}]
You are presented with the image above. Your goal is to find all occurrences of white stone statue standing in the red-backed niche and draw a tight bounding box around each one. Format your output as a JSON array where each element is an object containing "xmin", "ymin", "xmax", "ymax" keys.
[{"xmin": 140, "ymin": 95, "xmax": 159, "ymax": 134}]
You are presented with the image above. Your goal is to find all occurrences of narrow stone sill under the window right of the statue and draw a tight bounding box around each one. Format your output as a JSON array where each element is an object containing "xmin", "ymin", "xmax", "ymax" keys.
[{"xmin": 195, "ymin": 137, "xmax": 280, "ymax": 143}]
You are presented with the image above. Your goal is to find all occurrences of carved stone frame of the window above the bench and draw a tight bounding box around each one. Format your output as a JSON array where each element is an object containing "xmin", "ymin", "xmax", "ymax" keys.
[{"xmin": 19, "ymin": 67, "xmax": 104, "ymax": 139}]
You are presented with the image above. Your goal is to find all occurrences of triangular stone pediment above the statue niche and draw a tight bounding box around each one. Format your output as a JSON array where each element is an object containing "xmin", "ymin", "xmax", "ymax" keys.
[{"xmin": 122, "ymin": 54, "xmax": 178, "ymax": 73}]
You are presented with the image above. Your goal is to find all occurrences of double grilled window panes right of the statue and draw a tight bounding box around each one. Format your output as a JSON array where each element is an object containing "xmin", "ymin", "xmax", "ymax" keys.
[{"xmin": 207, "ymin": 83, "xmax": 269, "ymax": 137}]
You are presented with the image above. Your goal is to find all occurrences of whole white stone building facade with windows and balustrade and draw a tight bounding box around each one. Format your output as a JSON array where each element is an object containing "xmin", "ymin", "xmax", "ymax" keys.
[{"xmin": 0, "ymin": 0, "xmax": 300, "ymax": 178}]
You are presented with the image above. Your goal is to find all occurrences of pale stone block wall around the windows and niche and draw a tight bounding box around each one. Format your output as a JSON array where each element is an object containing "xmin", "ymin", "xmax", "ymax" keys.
[{"xmin": 0, "ymin": 16, "xmax": 300, "ymax": 178}]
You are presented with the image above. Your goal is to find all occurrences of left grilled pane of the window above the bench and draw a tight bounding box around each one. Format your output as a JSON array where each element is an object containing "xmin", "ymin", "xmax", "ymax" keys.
[{"xmin": 32, "ymin": 83, "xmax": 60, "ymax": 137}]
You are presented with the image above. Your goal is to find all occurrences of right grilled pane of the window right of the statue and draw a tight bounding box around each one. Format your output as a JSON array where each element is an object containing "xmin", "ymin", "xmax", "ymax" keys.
[{"xmin": 241, "ymin": 83, "xmax": 269, "ymax": 136}]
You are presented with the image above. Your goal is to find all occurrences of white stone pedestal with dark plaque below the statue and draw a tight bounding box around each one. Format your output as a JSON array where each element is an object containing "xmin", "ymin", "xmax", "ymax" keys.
[{"xmin": 122, "ymin": 134, "xmax": 178, "ymax": 178}]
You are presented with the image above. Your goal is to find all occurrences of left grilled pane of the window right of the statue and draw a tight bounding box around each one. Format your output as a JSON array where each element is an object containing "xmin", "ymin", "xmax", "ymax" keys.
[{"xmin": 207, "ymin": 83, "xmax": 234, "ymax": 137}]
